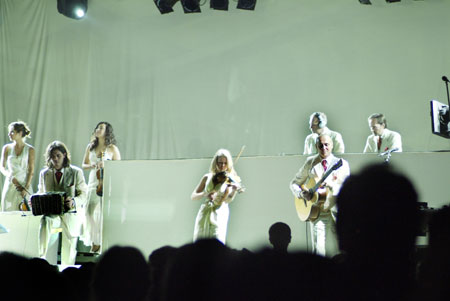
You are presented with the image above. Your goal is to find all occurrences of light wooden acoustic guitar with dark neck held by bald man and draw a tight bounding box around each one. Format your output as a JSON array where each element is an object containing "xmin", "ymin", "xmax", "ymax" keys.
[{"xmin": 295, "ymin": 159, "xmax": 342, "ymax": 222}]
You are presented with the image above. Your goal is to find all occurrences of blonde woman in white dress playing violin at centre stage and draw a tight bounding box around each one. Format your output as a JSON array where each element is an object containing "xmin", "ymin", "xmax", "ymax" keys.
[{"xmin": 191, "ymin": 149, "xmax": 242, "ymax": 244}]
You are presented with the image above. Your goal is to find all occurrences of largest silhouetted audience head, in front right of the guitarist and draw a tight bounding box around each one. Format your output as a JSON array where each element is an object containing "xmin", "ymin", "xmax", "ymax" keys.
[{"xmin": 336, "ymin": 165, "xmax": 419, "ymax": 257}]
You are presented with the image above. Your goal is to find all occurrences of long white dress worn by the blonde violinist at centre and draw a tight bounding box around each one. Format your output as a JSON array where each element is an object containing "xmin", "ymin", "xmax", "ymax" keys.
[{"xmin": 194, "ymin": 173, "xmax": 230, "ymax": 244}]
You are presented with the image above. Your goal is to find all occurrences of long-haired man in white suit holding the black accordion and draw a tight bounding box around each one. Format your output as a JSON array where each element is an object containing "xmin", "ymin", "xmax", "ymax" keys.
[{"xmin": 39, "ymin": 141, "xmax": 87, "ymax": 265}]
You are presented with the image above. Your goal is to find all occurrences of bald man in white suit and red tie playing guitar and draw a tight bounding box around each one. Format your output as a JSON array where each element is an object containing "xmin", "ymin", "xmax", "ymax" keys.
[{"xmin": 290, "ymin": 134, "xmax": 350, "ymax": 256}]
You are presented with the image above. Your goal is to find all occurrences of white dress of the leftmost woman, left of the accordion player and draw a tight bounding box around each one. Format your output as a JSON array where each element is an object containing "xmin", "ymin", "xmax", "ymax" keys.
[{"xmin": 2, "ymin": 143, "xmax": 33, "ymax": 211}]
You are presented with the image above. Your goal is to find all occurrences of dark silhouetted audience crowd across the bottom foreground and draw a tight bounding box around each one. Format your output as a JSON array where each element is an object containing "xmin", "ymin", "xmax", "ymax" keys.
[{"xmin": 0, "ymin": 165, "xmax": 450, "ymax": 301}]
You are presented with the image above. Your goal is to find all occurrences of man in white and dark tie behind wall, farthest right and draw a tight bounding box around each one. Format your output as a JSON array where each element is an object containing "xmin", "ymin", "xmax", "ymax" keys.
[{"xmin": 364, "ymin": 113, "xmax": 402, "ymax": 153}]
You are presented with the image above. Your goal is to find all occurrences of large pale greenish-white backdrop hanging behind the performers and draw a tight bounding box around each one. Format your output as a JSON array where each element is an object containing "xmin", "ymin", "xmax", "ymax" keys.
[{"xmin": 0, "ymin": 0, "xmax": 450, "ymax": 205}]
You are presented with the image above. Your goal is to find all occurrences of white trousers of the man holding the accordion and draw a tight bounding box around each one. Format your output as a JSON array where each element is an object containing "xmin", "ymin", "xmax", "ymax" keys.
[{"xmin": 39, "ymin": 215, "xmax": 78, "ymax": 265}]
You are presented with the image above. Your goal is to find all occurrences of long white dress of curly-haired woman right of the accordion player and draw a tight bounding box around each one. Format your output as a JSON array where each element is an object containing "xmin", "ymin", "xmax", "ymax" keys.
[{"xmin": 80, "ymin": 150, "xmax": 113, "ymax": 246}]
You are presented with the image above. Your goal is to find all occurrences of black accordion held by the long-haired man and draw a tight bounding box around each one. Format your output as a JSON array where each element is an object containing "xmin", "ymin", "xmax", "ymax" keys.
[{"xmin": 31, "ymin": 192, "xmax": 69, "ymax": 215}]
